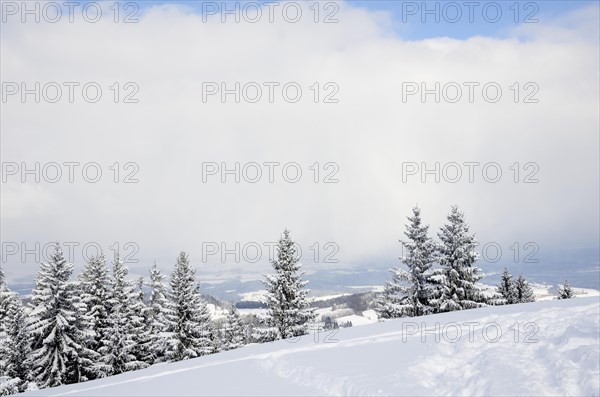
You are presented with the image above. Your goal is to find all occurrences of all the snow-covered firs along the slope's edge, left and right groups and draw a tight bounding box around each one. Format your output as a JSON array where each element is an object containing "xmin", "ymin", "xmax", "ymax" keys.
[{"xmin": 0, "ymin": 220, "xmax": 573, "ymax": 395}]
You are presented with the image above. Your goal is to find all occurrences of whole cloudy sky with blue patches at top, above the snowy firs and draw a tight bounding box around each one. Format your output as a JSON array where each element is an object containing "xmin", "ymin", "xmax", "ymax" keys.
[{"xmin": 0, "ymin": 1, "xmax": 600, "ymax": 281}]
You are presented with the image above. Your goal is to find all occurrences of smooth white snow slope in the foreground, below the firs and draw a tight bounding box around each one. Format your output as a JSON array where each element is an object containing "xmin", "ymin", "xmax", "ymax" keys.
[{"xmin": 24, "ymin": 297, "xmax": 600, "ymax": 396}]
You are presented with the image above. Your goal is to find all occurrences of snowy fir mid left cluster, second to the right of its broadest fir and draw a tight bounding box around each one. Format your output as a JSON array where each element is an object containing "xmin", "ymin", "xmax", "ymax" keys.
[{"xmin": 100, "ymin": 253, "xmax": 147, "ymax": 375}]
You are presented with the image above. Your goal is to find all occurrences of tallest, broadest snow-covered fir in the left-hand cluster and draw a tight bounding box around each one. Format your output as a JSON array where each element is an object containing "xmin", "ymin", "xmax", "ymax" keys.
[{"xmin": 27, "ymin": 244, "xmax": 81, "ymax": 388}]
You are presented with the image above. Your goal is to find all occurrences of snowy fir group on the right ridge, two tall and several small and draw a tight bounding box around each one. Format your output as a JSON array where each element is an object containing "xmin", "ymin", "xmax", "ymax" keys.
[{"xmin": 376, "ymin": 206, "xmax": 556, "ymax": 319}]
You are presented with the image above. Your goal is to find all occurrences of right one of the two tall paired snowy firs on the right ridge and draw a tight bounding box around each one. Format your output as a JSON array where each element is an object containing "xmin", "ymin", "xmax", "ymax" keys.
[{"xmin": 432, "ymin": 206, "xmax": 486, "ymax": 312}]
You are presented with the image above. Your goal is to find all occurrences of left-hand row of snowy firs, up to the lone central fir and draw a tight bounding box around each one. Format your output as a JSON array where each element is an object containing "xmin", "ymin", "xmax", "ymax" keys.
[{"xmin": 0, "ymin": 230, "xmax": 314, "ymax": 395}]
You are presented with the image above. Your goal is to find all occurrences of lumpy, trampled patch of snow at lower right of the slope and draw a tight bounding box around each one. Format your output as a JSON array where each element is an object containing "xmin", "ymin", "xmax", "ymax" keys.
[{"xmin": 412, "ymin": 307, "xmax": 600, "ymax": 396}]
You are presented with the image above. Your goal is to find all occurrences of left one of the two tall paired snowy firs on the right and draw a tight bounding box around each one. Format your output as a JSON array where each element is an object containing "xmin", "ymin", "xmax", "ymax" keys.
[{"xmin": 379, "ymin": 207, "xmax": 435, "ymax": 318}]
